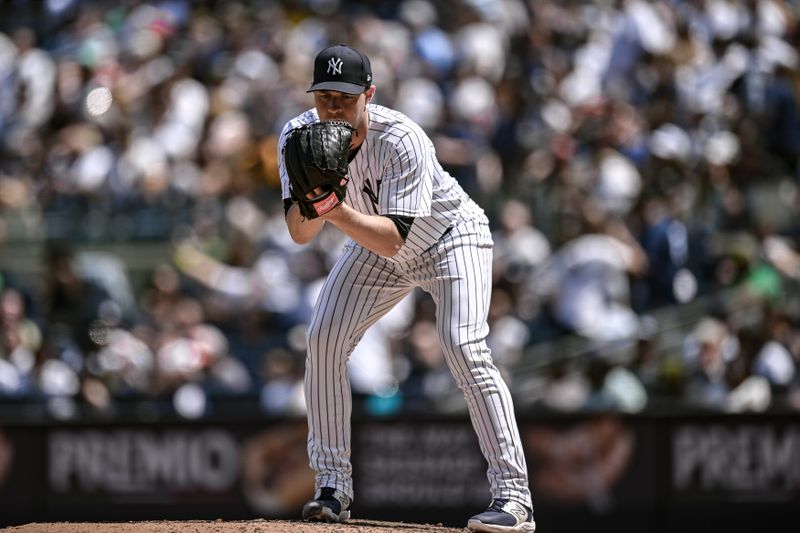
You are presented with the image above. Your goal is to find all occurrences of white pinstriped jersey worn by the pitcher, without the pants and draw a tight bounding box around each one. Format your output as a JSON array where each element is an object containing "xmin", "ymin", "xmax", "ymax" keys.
[{"xmin": 278, "ymin": 104, "xmax": 485, "ymax": 262}]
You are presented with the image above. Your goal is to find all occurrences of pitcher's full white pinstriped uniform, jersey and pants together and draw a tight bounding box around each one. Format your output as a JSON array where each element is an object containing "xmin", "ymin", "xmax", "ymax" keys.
[{"xmin": 279, "ymin": 105, "xmax": 531, "ymax": 507}]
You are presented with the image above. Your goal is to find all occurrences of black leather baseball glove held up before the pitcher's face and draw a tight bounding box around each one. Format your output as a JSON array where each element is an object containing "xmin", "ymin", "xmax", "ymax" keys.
[{"xmin": 283, "ymin": 120, "xmax": 354, "ymax": 218}]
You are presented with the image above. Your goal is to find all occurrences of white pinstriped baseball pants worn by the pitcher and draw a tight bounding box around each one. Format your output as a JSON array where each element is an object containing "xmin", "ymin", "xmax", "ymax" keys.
[{"xmin": 305, "ymin": 218, "xmax": 531, "ymax": 507}]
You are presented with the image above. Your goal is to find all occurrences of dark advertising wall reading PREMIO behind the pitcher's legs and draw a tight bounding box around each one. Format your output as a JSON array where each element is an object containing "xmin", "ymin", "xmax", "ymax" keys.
[{"xmin": 0, "ymin": 416, "xmax": 800, "ymax": 532}]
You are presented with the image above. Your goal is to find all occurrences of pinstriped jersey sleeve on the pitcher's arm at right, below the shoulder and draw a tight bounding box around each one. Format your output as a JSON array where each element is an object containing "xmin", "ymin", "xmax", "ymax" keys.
[{"xmin": 379, "ymin": 130, "xmax": 433, "ymax": 217}]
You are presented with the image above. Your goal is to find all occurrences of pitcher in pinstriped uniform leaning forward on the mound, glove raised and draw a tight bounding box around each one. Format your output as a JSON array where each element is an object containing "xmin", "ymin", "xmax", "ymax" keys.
[{"xmin": 279, "ymin": 45, "xmax": 535, "ymax": 532}]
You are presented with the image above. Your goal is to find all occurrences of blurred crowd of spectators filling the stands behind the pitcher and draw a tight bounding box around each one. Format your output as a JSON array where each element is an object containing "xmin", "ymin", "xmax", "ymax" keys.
[{"xmin": 0, "ymin": 0, "xmax": 800, "ymax": 418}]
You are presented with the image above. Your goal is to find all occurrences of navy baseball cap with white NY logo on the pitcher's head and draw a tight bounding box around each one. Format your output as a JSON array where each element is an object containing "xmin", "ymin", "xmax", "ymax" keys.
[{"xmin": 306, "ymin": 44, "xmax": 372, "ymax": 94}]
